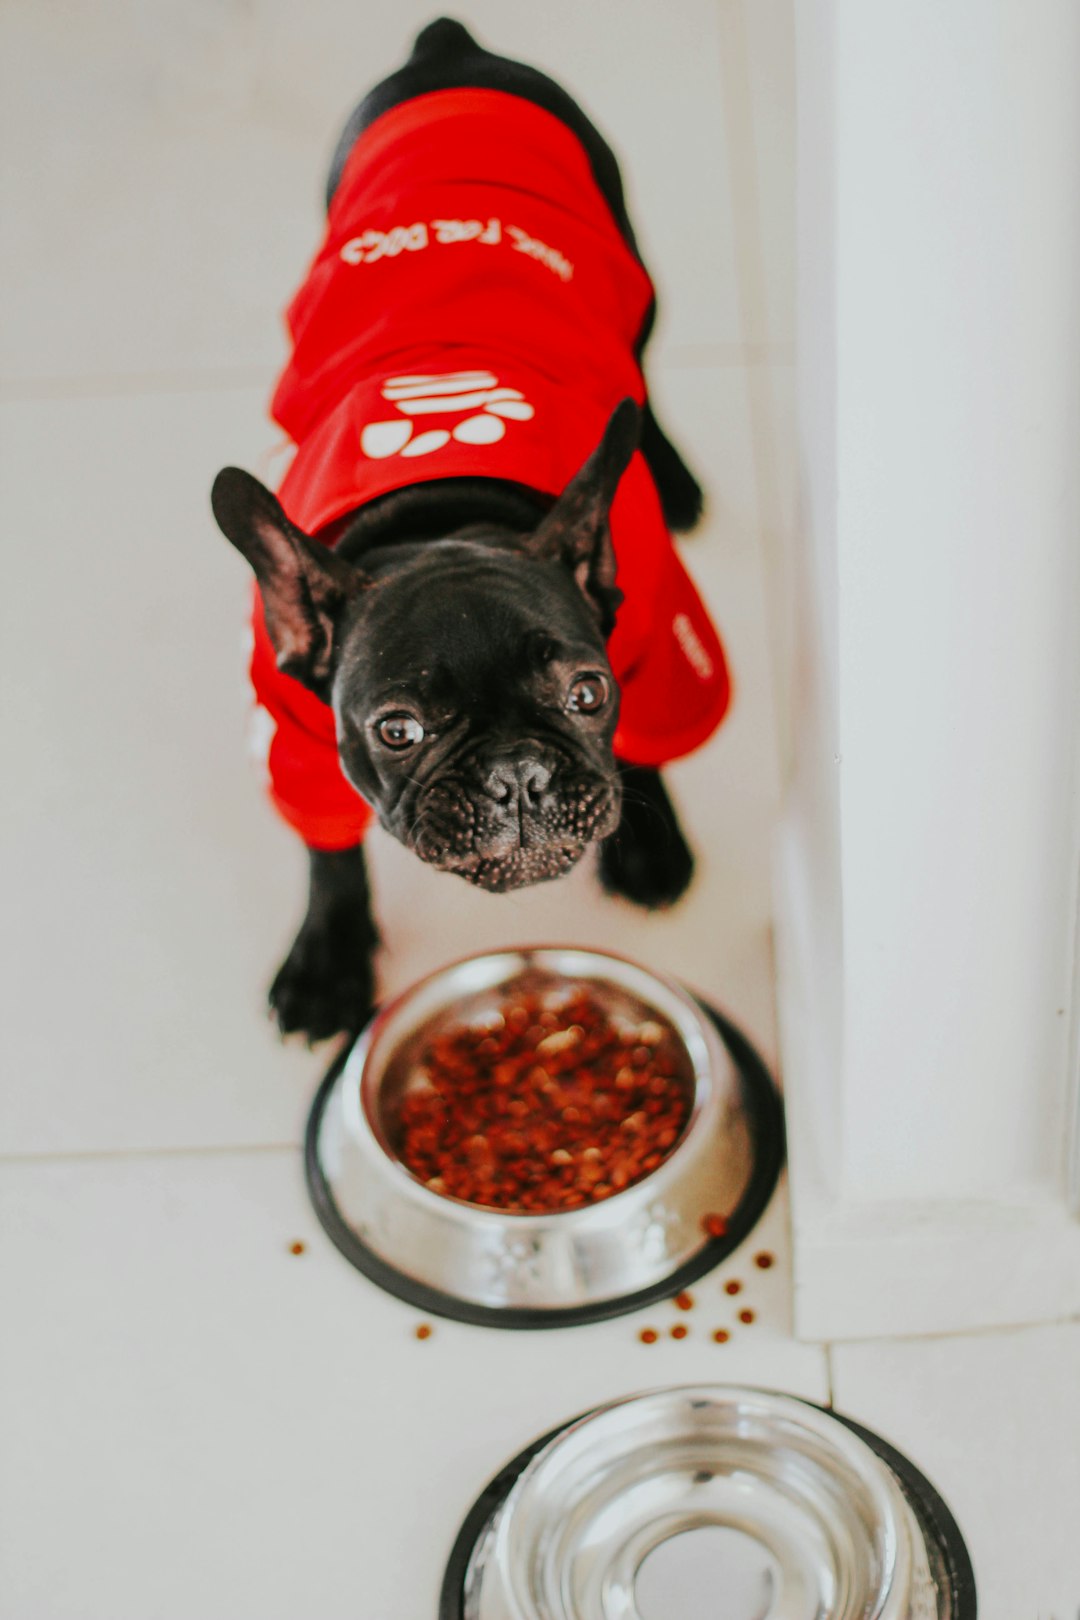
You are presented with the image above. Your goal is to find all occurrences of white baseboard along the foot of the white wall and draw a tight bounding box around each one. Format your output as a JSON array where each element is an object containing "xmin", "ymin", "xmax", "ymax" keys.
[{"xmin": 776, "ymin": 822, "xmax": 1080, "ymax": 1341}]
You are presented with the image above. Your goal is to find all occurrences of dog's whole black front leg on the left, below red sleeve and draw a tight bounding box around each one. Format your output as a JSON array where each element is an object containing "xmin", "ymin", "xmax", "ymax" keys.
[{"xmin": 270, "ymin": 846, "xmax": 379, "ymax": 1040}]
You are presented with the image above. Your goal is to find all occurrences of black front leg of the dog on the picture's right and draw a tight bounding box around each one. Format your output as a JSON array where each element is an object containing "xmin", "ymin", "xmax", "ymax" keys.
[{"xmin": 599, "ymin": 760, "xmax": 693, "ymax": 910}]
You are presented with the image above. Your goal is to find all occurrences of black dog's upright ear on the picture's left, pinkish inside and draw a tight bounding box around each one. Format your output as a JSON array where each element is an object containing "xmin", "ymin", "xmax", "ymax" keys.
[{"xmin": 210, "ymin": 467, "xmax": 366, "ymax": 697}]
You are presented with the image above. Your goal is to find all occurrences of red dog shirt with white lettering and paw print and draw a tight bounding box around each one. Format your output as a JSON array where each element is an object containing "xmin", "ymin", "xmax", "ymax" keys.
[{"xmin": 251, "ymin": 89, "xmax": 730, "ymax": 849}]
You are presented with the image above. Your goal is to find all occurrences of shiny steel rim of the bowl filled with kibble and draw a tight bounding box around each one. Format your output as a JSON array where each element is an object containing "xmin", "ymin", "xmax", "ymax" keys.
[{"xmin": 343, "ymin": 944, "xmax": 717, "ymax": 1228}]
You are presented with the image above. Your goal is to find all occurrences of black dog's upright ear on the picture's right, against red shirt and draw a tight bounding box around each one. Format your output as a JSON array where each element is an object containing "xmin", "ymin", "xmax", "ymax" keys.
[{"xmin": 528, "ymin": 399, "xmax": 641, "ymax": 637}]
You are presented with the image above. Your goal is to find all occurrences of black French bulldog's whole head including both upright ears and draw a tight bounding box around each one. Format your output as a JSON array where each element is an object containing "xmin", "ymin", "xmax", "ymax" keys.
[{"xmin": 212, "ymin": 400, "xmax": 640, "ymax": 891}]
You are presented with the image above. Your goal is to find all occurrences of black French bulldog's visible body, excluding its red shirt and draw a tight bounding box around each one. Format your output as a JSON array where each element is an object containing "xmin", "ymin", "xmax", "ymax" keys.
[{"xmin": 212, "ymin": 19, "xmax": 701, "ymax": 1040}]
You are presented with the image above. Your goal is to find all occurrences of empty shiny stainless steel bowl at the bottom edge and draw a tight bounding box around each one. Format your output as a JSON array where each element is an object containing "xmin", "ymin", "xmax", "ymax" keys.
[{"xmin": 442, "ymin": 1385, "xmax": 975, "ymax": 1620}]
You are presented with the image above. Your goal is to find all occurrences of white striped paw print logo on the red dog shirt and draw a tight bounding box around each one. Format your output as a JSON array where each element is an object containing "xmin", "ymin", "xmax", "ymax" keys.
[{"xmin": 359, "ymin": 371, "xmax": 533, "ymax": 462}]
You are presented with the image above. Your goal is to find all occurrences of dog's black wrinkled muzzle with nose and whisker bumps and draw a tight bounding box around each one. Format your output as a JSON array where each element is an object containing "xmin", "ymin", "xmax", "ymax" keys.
[{"xmin": 411, "ymin": 755, "xmax": 619, "ymax": 894}]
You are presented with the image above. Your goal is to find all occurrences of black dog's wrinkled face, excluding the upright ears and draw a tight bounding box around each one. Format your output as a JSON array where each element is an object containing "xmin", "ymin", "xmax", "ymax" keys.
[{"xmin": 332, "ymin": 539, "xmax": 619, "ymax": 891}]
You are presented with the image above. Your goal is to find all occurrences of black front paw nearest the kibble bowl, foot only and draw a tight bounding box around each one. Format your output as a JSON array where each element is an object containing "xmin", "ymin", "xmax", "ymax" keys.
[{"xmin": 269, "ymin": 907, "xmax": 374, "ymax": 1042}]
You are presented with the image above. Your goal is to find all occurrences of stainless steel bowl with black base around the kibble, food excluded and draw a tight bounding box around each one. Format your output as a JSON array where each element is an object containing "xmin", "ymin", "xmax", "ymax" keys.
[{"xmin": 308, "ymin": 948, "xmax": 782, "ymax": 1327}]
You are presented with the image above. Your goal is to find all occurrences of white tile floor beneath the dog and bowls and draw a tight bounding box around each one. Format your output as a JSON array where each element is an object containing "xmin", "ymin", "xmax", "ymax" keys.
[{"xmin": 0, "ymin": 0, "xmax": 1080, "ymax": 1620}]
